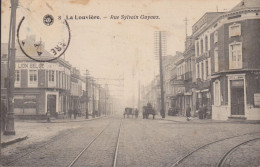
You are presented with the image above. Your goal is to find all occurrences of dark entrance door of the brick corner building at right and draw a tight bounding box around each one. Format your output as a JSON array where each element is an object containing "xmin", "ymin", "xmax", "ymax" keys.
[{"xmin": 231, "ymin": 80, "xmax": 245, "ymax": 115}]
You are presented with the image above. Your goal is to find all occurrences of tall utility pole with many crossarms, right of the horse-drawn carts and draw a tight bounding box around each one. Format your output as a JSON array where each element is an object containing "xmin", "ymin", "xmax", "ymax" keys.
[{"xmin": 159, "ymin": 31, "xmax": 165, "ymax": 118}]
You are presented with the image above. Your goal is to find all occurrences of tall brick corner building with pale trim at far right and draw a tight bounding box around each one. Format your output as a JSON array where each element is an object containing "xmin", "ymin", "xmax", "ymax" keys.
[{"xmin": 195, "ymin": 0, "xmax": 260, "ymax": 120}]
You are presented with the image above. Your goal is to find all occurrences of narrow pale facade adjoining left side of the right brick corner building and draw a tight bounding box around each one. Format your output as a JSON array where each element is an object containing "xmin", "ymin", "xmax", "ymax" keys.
[{"xmin": 192, "ymin": 12, "xmax": 223, "ymax": 117}]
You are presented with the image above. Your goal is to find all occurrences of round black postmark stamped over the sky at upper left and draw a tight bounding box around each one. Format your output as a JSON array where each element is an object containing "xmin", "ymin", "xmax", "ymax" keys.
[{"xmin": 17, "ymin": 14, "xmax": 71, "ymax": 62}]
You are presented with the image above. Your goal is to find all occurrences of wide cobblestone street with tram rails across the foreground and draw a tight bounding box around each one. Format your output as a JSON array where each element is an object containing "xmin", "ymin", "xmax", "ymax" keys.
[{"xmin": 2, "ymin": 116, "xmax": 260, "ymax": 167}]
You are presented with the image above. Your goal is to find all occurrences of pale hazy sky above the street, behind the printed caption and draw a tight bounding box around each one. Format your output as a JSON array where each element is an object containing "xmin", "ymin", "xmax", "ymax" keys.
[{"xmin": 1, "ymin": 0, "xmax": 240, "ymax": 105}]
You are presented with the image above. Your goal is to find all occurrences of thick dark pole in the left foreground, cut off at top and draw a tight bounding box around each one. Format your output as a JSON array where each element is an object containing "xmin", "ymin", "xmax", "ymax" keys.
[{"xmin": 4, "ymin": 0, "xmax": 18, "ymax": 135}]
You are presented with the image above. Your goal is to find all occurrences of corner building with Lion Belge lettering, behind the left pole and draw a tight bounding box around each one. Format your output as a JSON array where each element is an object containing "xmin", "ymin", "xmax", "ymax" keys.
[{"xmin": 1, "ymin": 44, "xmax": 71, "ymax": 119}]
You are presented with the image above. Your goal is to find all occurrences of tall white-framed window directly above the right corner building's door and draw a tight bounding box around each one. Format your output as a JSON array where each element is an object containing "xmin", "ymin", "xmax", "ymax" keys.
[{"xmin": 229, "ymin": 42, "xmax": 242, "ymax": 69}]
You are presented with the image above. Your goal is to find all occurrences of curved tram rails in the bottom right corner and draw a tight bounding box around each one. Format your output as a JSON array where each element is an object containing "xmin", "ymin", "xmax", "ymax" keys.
[{"xmin": 170, "ymin": 132, "xmax": 260, "ymax": 167}]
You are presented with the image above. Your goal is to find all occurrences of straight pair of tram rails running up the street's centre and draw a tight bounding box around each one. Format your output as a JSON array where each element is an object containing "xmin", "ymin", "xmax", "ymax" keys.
[{"xmin": 68, "ymin": 119, "xmax": 122, "ymax": 167}]
